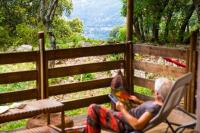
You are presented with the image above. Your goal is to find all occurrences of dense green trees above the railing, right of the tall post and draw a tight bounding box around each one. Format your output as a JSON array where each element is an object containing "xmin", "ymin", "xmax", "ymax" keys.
[{"xmin": 121, "ymin": 0, "xmax": 198, "ymax": 43}]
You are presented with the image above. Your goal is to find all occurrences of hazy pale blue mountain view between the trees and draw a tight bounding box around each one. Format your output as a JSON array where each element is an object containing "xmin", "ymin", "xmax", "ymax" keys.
[{"xmin": 70, "ymin": 0, "xmax": 124, "ymax": 39}]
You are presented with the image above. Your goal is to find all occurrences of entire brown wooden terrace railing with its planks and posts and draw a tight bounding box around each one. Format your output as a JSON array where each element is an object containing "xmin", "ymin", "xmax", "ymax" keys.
[{"xmin": 0, "ymin": 32, "xmax": 195, "ymax": 111}]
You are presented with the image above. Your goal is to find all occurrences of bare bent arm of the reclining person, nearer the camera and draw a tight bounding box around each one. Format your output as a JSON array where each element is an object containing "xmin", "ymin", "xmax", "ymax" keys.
[{"xmin": 116, "ymin": 102, "xmax": 153, "ymax": 130}]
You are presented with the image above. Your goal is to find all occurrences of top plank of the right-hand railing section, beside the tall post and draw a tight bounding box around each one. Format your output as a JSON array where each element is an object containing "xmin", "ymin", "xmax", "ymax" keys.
[{"xmin": 133, "ymin": 44, "xmax": 187, "ymax": 59}]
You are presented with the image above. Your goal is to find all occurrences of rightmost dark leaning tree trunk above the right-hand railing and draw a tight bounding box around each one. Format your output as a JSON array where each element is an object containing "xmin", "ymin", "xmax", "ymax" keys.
[{"xmin": 178, "ymin": 4, "xmax": 195, "ymax": 42}]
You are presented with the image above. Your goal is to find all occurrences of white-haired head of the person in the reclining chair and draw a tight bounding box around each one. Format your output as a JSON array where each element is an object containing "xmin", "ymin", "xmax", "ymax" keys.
[{"xmin": 155, "ymin": 78, "xmax": 173, "ymax": 102}]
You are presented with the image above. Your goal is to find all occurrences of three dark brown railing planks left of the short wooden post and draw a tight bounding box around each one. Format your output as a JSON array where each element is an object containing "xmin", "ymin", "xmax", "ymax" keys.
[{"xmin": 0, "ymin": 52, "xmax": 40, "ymax": 104}]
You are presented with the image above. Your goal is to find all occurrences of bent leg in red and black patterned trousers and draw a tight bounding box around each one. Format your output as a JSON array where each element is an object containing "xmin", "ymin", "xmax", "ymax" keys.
[{"xmin": 86, "ymin": 104, "xmax": 123, "ymax": 133}]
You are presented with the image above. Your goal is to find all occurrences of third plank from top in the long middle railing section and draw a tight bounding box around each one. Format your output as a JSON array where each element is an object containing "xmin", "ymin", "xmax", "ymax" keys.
[{"xmin": 49, "ymin": 78, "xmax": 112, "ymax": 96}]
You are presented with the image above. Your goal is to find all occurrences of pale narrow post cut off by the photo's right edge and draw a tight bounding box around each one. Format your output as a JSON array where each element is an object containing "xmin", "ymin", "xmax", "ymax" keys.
[{"xmin": 196, "ymin": 29, "xmax": 200, "ymax": 132}]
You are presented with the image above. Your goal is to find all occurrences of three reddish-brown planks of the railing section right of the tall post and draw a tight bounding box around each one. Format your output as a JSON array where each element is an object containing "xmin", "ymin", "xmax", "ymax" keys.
[{"xmin": 133, "ymin": 44, "xmax": 188, "ymax": 89}]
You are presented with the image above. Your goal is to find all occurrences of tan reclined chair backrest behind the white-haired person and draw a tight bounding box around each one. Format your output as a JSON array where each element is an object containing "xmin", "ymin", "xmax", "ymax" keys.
[{"xmin": 144, "ymin": 73, "xmax": 192, "ymax": 131}]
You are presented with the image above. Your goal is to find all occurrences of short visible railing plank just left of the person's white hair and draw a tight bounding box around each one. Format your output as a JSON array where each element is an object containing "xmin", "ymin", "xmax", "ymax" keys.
[{"xmin": 133, "ymin": 77, "xmax": 154, "ymax": 90}]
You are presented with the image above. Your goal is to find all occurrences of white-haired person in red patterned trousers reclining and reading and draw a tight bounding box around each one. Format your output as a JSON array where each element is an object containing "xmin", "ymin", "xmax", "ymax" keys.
[{"xmin": 85, "ymin": 78, "xmax": 173, "ymax": 133}]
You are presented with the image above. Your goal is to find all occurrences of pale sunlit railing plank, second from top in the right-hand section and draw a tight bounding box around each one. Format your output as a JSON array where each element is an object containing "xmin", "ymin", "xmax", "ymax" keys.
[{"xmin": 133, "ymin": 61, "xmax": 187, "ymax": 77}]
